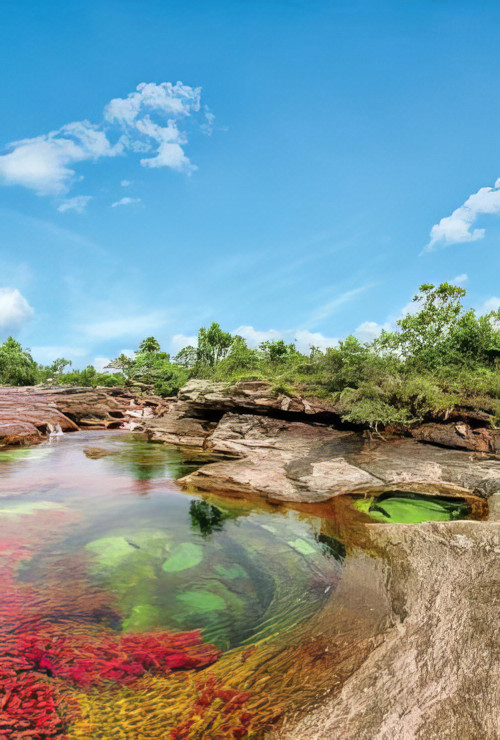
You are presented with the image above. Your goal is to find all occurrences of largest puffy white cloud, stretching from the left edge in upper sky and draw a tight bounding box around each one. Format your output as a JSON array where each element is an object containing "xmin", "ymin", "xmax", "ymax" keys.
[{"xmin": 0, "ymin": 82, "xmax": 213, "ymax": 195}]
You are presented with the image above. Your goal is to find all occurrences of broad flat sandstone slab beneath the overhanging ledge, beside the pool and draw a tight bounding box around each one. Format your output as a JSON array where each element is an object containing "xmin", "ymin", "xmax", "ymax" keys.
[{"xmin": 176, "ymin": 413, "xmax": 500, "ymax": 502}]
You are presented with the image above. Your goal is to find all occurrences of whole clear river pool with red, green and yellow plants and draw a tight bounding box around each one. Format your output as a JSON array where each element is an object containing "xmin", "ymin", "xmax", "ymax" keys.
[{"xmin": 0, "ymin": 432, "xmax": 386, "ymax": 738}]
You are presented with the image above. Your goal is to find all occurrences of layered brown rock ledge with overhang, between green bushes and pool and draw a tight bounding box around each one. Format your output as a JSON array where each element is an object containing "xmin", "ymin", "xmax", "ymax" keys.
[{"xmin": 145, "ymin": 381, "xmax": 500, "ymax": 502}]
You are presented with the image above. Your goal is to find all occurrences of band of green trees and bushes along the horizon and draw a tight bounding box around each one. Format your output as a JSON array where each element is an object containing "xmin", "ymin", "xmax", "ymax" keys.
[{"xmin": 0, "ymin": 283, "xmax": 500, "ymax": 429}]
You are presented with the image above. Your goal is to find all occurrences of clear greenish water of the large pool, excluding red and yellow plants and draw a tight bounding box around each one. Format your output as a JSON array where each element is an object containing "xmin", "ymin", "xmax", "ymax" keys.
[{"xmin": 0, "ymin": 432, "xmax": 344, "ymax": 650}]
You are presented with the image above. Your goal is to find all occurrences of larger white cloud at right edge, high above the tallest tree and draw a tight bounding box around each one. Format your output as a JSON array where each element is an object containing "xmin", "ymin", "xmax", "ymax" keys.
[{"xmin": 423, "ymin": 179, "xmax": 500, "ymax": 252}]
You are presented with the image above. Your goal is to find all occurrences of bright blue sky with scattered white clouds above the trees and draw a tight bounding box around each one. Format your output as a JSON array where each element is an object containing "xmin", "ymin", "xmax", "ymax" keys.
[{"xmin": 0, "ymin": 0, "xmax": 500, "ymax": 366}]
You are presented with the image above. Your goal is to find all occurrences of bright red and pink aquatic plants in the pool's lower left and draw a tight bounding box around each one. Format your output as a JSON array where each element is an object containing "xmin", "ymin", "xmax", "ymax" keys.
[{"xmin": 0, "ymin": 512, "xmax": 220, "ymax": 740}]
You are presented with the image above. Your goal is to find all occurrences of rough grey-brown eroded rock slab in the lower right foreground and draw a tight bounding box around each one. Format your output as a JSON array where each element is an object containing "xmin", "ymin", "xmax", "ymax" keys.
[{"xmin": 278, "ymin": 521, "xmax": 500, "ymax": 740}]
